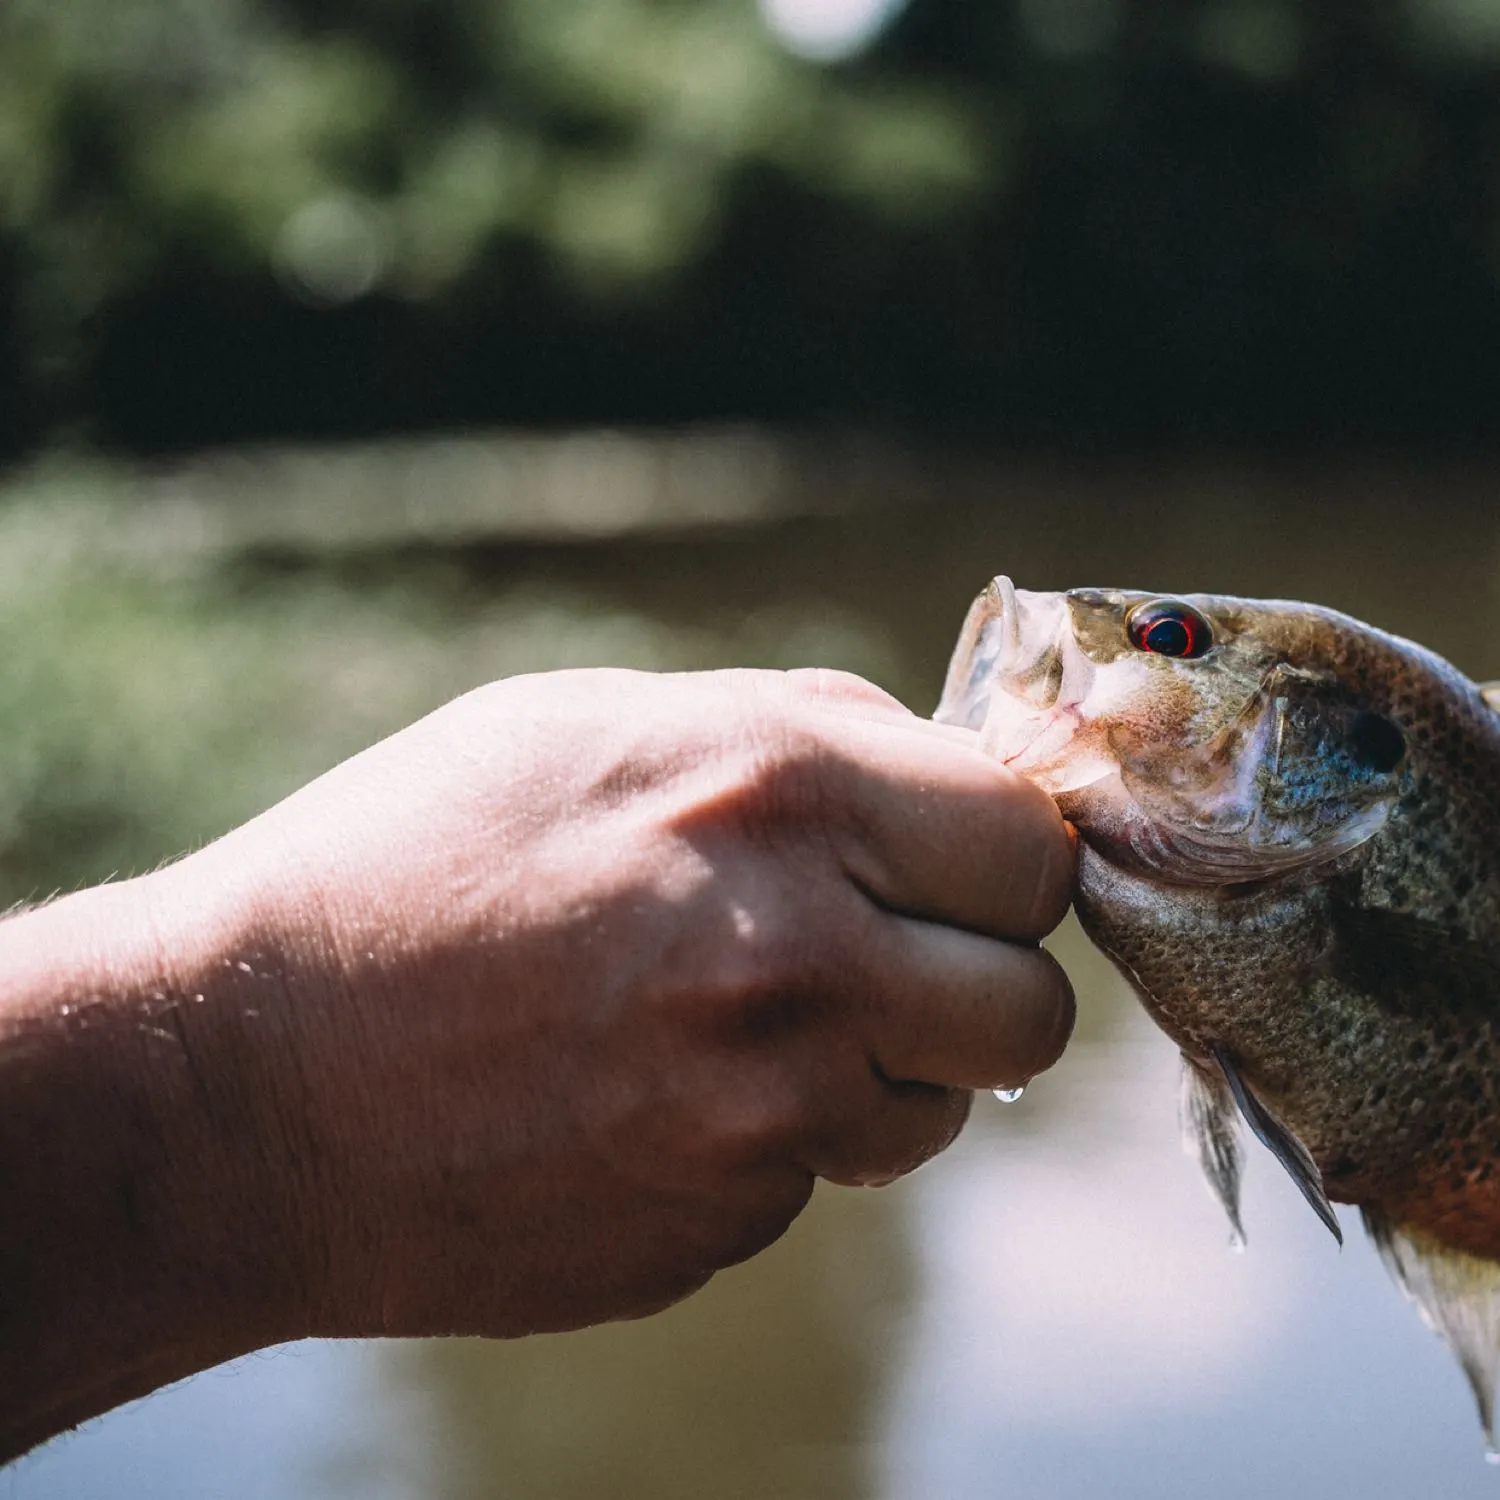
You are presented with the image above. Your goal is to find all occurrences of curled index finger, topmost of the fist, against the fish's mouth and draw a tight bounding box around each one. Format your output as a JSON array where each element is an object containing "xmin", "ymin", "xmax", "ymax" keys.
[{"xmin": 825, "ymin": 719, "xmax": 1076, "ymax": 942}]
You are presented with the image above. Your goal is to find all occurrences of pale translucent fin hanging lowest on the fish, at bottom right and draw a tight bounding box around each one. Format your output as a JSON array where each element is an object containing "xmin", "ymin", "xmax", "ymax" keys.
[{"xmin": 1361, "ymin": 1208, "xmax": 1500, "ymax": 1461}]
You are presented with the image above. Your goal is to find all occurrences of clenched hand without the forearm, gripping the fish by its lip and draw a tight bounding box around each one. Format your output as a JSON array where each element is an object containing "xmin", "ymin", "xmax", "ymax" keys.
[{"xmin": 174, "ymin": 671, "xmax": 1073, "ymax": 1335}]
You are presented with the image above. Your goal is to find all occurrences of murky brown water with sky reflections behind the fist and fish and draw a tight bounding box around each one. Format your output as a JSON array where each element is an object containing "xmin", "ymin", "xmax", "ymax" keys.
[{"xmin": 0, "ymin": 456, "xmax": 1500, "ymax": 1500}]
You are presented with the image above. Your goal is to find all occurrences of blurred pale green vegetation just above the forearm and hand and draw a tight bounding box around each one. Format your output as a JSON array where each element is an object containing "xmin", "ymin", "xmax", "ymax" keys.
[{"xmin": 0, "ymin": 473, "xmax": 900, "ymax": 911}]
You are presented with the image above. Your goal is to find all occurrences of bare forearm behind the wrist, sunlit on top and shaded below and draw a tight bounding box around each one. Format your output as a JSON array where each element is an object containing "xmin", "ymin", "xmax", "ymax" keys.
[{"xmin": 0, "ymin": 864, "xmax": 302, "ymax": 1457}]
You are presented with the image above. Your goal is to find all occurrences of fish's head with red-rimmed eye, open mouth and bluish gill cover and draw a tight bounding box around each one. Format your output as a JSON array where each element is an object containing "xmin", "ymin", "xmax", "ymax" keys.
[{"xmin": 936, "ymin": 578, "xmax": 1407, "ymax": 885}]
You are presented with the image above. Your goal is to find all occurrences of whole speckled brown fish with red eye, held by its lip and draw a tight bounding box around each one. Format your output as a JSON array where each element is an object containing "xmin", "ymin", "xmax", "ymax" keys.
[{"xmin": 935, "ymin": 578, "xmax": 1500, "ymax": 1463}]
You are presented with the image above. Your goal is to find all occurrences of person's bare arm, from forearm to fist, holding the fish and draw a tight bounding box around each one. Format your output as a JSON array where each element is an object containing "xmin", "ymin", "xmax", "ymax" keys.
[{"xmin": 0, "ymin": 672, "xmax": 1073, "ymax": 1460}]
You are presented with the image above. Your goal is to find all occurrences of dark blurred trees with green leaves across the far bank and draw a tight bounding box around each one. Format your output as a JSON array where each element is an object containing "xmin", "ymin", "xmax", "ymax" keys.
[{"xmin": 0, "ymin": 0, "xmax": 1500, "ymax": 453}]
